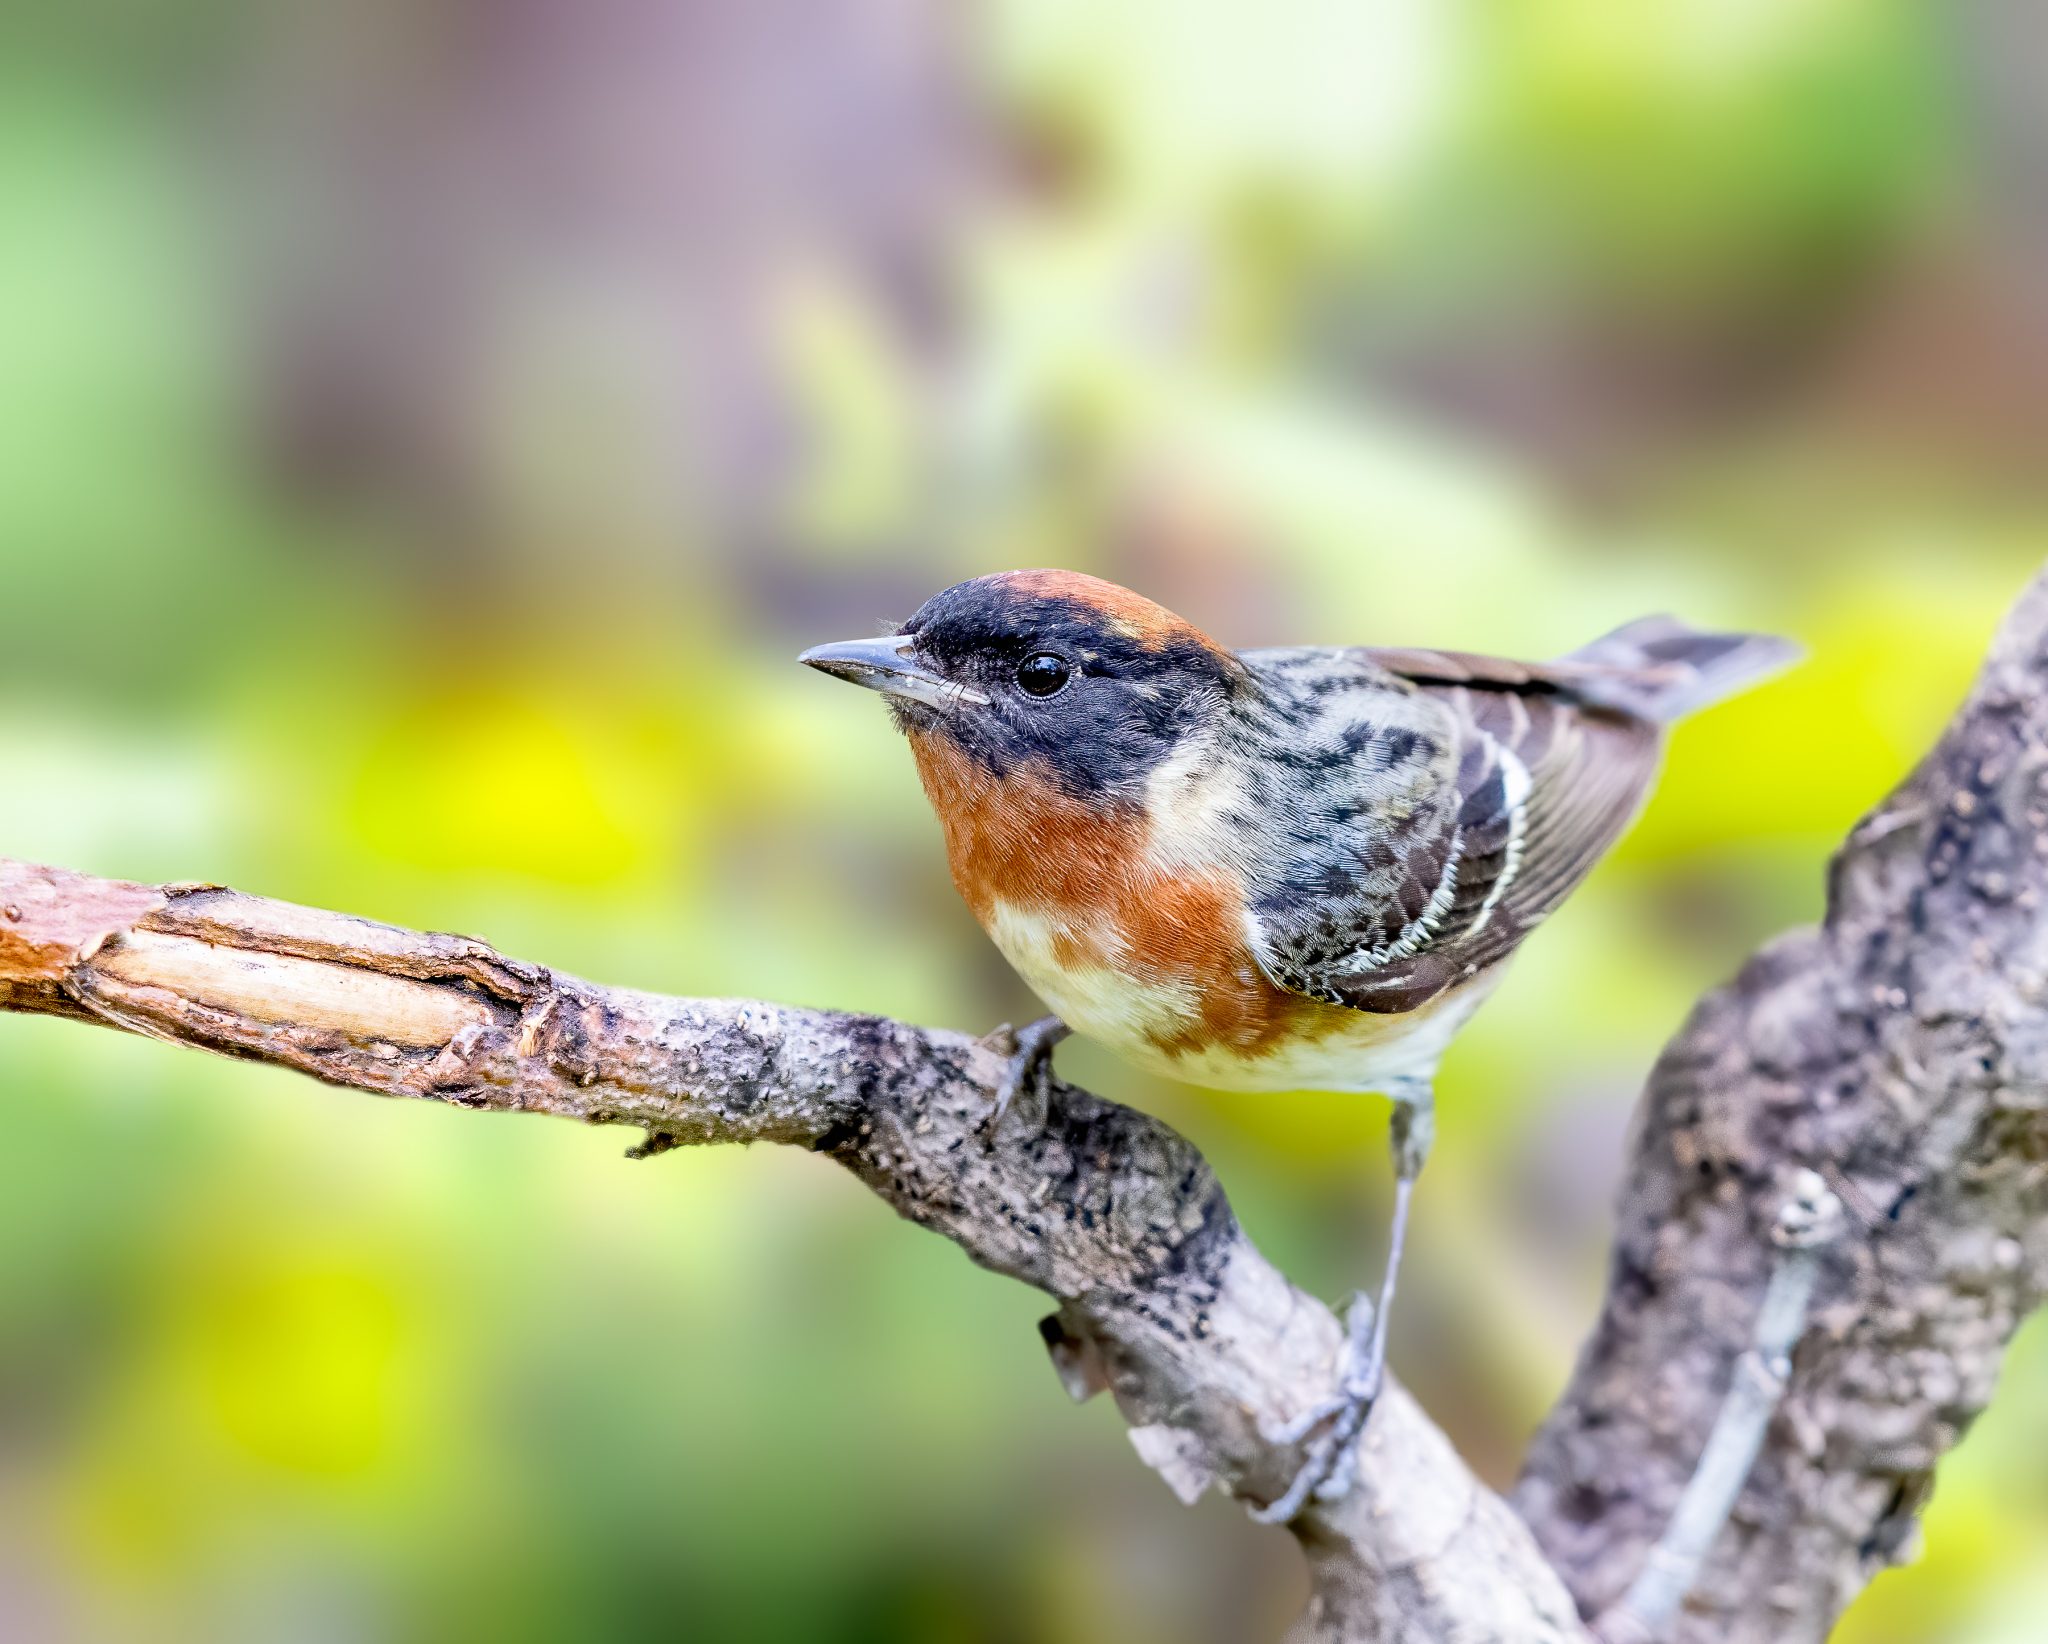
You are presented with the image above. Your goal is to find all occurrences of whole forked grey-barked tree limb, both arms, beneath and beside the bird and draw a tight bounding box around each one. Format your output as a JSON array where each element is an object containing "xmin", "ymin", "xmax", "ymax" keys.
[{"xmin": 0, "ymin": 560, "xmax": 2048, "ymax": 1644}]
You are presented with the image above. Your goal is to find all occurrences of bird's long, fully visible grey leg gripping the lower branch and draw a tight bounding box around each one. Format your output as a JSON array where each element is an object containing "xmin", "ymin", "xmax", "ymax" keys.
[{"xmin": 1251, "ymin": 1079, "xmax": 1436, "ymax": 1523}]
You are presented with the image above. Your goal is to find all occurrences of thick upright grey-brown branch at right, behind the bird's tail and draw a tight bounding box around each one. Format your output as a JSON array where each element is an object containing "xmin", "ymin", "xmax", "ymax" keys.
[{"xmin": 1513, "ymin": 560, "xmax": 2048, "ymax": 1644}]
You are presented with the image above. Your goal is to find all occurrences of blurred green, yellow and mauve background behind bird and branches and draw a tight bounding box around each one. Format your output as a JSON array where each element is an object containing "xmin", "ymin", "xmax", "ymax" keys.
[{"xmin": 0, "ymin": 0, "xmax": 2048, "ymax": 1644}]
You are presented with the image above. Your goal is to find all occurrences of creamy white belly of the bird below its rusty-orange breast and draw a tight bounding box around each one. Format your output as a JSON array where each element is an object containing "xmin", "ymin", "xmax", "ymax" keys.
[{"xmin": 989, "ymin": 903, "xmax": 1493, "ymax": 1091}]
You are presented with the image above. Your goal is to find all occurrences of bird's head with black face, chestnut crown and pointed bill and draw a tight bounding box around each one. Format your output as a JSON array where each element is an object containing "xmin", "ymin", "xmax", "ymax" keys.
[{"xmin": 799, "ymin": 571, "xmax": 1243, "ymax": 803}]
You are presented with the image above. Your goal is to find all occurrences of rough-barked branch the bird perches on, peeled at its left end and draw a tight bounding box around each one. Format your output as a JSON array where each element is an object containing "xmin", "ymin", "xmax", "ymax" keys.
[{"xmin": 0, "ymin": 860, "xmax": 1585, "ymax": 1644}]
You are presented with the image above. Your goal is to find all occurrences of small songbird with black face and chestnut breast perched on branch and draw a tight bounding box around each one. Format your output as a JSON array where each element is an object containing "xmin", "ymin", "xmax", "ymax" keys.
[{"xmin": 801, "ymin": 571, "xmax": 1794, "ymax": 1521}]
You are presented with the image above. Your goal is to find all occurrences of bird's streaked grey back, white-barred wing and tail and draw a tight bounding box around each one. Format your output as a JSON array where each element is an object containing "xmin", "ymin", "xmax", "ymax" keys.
[{"xmin": 1245, "ymin": 616, "xmax": 1796, "ymax": 1013}]
